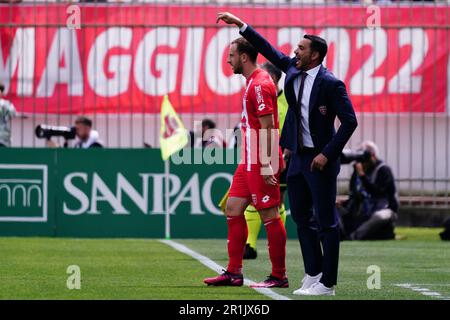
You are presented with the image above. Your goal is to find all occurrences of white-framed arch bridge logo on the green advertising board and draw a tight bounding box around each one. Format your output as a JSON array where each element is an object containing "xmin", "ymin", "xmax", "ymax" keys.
[{"xmin": 0, "ymin": 164, "xmax": 48, "ymax": 222}]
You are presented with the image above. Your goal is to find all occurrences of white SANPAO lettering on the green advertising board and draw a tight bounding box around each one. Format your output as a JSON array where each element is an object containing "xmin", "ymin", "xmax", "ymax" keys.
[{"xmin": 61, "ymin": 171, "xmax": 236, "ymax": 216}]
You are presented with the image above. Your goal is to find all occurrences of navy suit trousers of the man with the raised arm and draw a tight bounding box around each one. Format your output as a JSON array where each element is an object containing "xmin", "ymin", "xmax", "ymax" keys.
[{"xmin": 287, "ymin": 149, "xmax": 340, "ymax": 287}]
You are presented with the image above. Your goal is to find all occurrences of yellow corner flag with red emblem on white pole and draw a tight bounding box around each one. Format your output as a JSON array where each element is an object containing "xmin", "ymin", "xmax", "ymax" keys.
[{"xmin": 159, "ymin": 95, "xmax": 188, "ymax": 161}]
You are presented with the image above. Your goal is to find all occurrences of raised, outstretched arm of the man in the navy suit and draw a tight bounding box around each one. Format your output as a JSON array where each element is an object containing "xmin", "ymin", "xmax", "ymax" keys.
[{"xmin": 216, "ymin": 12, "xmax": 291, "ymax": 72}]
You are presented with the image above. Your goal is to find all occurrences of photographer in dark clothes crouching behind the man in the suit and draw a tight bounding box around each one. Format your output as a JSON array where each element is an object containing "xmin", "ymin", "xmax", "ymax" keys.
[{"xmin": 337, "ymin": 141, "xmax": 399, "ymax": 240}]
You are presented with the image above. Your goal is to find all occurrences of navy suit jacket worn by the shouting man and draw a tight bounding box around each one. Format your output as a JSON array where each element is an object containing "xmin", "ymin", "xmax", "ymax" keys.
[{"xmin": 241, "ymin": 26, "xmax": 358, "ymax": 172}]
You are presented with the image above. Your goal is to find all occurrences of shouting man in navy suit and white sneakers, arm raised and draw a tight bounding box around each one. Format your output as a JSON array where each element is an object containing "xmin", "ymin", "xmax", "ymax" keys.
[{"xmin": 217, "ymin": 12, "xmax": 357, "ymax": 295}]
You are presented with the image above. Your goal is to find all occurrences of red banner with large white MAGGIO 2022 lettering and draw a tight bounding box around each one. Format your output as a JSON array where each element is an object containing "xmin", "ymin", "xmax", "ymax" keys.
[{"xmin": 0, "ymin": 5, "xmax": 450, "ymax": 114}]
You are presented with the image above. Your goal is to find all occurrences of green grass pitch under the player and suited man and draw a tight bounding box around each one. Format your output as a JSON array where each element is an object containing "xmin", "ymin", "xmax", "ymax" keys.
[{"xmin": 0, "ymin": 228, "xmax": 450, "ymax": 300}]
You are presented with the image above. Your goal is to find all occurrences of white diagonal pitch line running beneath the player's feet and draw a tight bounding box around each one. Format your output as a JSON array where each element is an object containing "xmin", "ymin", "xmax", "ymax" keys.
[{"xmin": 159, "ymin": 240, "xmax": 291, "ymax": 300}]
